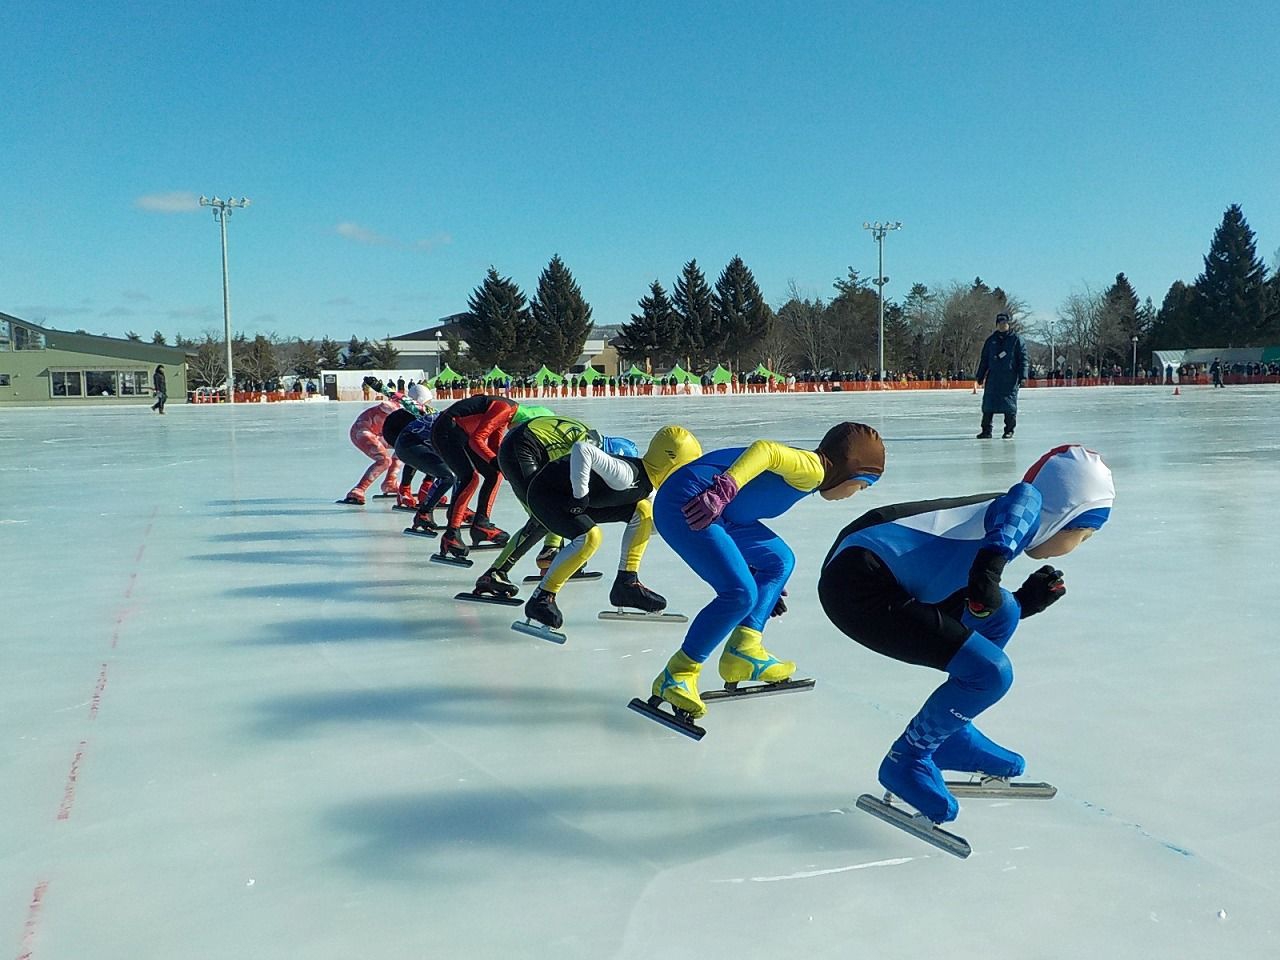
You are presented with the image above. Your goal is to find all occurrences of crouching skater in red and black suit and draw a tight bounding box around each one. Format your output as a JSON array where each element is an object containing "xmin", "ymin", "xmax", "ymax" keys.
[{"xmin": 431, "ymin": 393, "xmax": 520, "ymax": 558}]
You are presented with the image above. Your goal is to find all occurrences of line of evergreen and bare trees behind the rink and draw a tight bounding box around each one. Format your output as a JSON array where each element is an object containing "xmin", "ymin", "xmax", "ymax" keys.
[{"xmin": 115, "ymin": 204, "xmax": 1280, "ymax": 387}]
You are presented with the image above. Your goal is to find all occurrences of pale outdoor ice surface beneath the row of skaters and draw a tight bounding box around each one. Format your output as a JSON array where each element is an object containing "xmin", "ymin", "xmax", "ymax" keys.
[{"xmin": 0, "ymin": 387, "xmax": 1280, "ymax": 960}]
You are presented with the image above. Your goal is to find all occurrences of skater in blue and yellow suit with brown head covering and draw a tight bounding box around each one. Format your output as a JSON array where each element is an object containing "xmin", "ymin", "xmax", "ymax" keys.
[{"xmin": 653, "ymin": 422, "xmax": 884, "ymax": 718}]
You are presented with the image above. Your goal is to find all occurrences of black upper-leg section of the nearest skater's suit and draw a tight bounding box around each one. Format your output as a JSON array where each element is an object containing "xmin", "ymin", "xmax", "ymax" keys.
[{"xmin": 818, "ymin": 547, "xmax": 970, "ymax": 669}]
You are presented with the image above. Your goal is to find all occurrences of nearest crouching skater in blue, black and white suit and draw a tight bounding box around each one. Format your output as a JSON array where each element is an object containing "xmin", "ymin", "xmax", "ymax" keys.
[{"xmin": 818, "ymin": 444, "xmax": 1115, "ymax": 823}]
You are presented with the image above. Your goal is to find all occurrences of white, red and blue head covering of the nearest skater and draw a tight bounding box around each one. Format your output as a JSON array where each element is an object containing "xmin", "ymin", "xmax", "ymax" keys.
[{"xmin": 1023, "ymin": 443, "xmax": 1116, "ymax": 547}]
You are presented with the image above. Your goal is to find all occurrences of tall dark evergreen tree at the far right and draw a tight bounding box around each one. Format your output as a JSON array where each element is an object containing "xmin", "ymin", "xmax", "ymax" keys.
[{"xmin": 1193, "ymin": 204, "xmax": 1267, "ymax": 347}]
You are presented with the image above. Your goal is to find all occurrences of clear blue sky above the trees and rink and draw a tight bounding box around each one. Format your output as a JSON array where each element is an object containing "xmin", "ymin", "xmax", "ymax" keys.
[{"xmin": 0, "ymin": 0, "xmax": 1280, "ymax": 339}]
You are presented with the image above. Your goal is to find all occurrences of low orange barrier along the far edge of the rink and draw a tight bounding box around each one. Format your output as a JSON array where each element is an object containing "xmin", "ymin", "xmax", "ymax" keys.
[{"xmin": 189, "ymin": 374, "xmax": 1280, "ymax": 403}]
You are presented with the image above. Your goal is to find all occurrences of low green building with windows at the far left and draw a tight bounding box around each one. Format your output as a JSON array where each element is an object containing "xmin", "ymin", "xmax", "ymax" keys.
[{"xmin": 0, "ymin": 314, "xmax": 187, "ymax": 407}]
